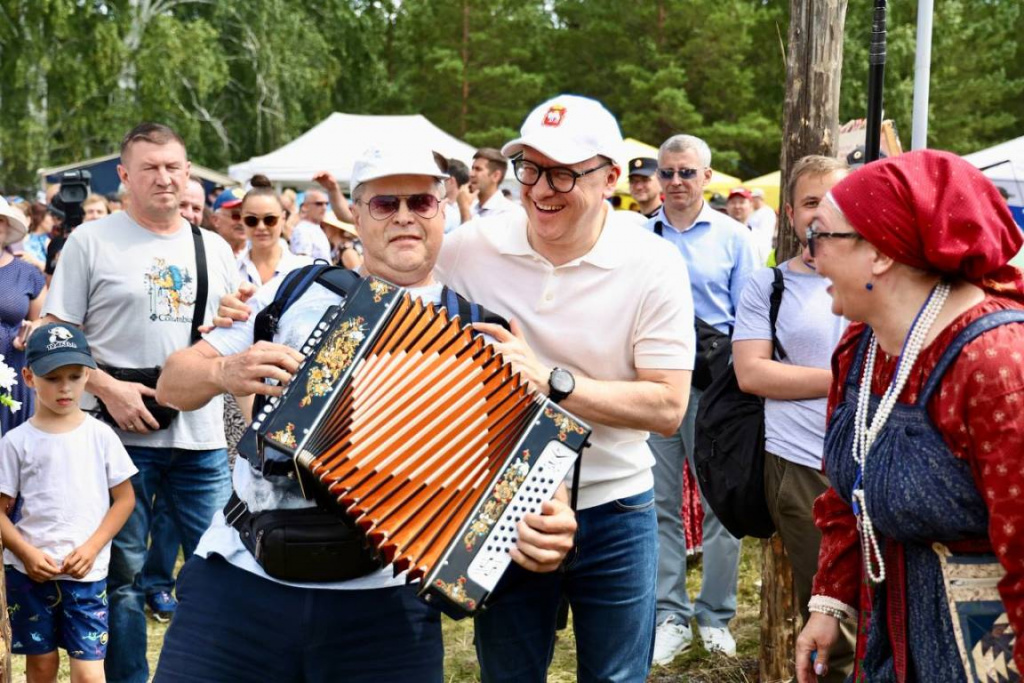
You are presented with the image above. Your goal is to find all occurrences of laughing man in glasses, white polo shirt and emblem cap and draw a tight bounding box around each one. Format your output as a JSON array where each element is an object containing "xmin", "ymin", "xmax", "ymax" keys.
[{"xmin": 437, "ymin": 95, "xmax": 694, "ymax": 683}]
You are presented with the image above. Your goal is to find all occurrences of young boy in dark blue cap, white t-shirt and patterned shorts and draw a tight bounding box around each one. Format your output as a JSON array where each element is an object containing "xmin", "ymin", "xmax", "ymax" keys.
[{"xmin": 0, "ymin": 324, "xmax": 137, "ymax": 682}]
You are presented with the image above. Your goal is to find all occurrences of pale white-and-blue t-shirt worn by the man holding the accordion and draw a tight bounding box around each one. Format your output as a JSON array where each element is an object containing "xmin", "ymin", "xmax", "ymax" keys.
[{"xmin": 196, "ymin": 278, "xmax": 441, "ymax": 590}]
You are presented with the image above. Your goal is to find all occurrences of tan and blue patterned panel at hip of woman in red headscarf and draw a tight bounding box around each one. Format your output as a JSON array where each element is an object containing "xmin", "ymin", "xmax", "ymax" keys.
[{"xmin": 932, "ymin": 543, "xmax": 1021, "ymax": 683}]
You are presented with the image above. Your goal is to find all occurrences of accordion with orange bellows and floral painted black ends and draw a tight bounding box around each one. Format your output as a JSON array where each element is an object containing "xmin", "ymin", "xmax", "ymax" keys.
[{"xmin": 239, "ymin": 278, "xmax": 591, "ymax": 615}]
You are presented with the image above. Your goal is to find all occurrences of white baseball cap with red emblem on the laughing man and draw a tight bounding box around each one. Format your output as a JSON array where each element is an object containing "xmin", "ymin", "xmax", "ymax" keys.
[{"xmin": 502, "ymin": 94, "xmax": 624, "ymax": 167}]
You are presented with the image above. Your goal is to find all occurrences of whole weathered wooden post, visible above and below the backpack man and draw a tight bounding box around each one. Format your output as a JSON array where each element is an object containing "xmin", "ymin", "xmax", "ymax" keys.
[{"xmin": 760, "ymin": 0, "xmax": 847, "ymax": 683}]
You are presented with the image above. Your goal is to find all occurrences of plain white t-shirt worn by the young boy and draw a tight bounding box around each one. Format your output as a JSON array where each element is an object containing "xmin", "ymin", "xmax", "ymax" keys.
[{"xmin": 0, "ymin": 415, "xmax": 138, "ymax": 581}]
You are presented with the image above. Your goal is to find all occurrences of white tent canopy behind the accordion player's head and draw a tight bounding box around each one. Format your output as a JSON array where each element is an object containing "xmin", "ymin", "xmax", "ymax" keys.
[{"xmin": 227, "ymin": 112, "xmax": 476, "ymax": 189}]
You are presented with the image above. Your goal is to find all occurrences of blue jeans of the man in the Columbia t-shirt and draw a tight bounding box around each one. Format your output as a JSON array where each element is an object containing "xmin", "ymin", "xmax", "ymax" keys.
[{"xmin": 104, "ymin": 446, "xmax": 231, "ymax": 683}]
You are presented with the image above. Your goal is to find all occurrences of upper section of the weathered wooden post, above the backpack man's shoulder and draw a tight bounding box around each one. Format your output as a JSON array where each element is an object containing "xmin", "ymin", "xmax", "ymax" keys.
[{"xmin": 776, "ymin": 0, "xmax": 847, "ymax": 263}]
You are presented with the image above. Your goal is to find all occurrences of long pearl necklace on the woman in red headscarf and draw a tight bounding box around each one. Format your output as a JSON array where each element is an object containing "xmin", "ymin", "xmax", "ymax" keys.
[{"xmin": 852, "ymin": 283, "xmax": 952, "ymax": 584}]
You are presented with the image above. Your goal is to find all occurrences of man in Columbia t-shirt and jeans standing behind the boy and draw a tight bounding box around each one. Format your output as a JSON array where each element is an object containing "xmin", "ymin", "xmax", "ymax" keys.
[{"xmin": 43, "ymin": 123, "xmax": 238, "ymax": 683}]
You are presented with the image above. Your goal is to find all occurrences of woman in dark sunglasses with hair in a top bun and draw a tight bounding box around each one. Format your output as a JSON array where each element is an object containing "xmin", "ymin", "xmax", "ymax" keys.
[{"xmin": 239, "ymin": 175, "xmax": 312, "ymax": 287}]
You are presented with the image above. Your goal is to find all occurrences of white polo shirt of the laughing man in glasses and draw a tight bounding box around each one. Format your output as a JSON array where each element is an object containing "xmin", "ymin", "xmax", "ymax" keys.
[{"xmin": 437, "ymin": 210, "xmax": 695, "ymax": 509}]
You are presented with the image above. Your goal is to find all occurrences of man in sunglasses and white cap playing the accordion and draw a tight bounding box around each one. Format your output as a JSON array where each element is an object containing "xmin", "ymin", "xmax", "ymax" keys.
[{"xmin": 149, "ymin": 141, "xmax": 575, "ymax": 683}]
